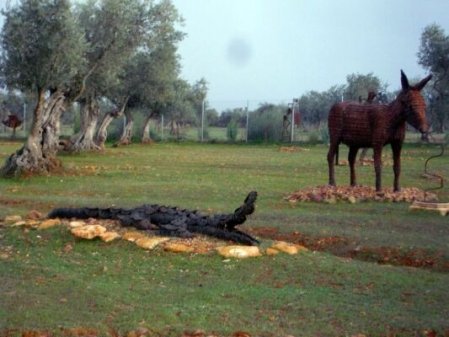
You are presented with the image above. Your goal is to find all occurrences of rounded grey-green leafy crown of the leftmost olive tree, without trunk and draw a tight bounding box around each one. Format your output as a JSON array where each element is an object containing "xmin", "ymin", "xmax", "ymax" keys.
[{"xmin": 1, "ymin": 0, "xmax": 87, "ymax": 91}]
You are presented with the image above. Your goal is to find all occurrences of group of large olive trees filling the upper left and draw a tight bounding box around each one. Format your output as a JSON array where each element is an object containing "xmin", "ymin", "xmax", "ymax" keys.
[{"xmin": 0, "ymin": 0, "xmax": 194, "ymax": 177}]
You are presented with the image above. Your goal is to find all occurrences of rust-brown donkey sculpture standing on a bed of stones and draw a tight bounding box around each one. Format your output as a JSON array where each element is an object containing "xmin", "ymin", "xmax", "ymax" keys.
[{"xmin": 327, "ymin": 70, "xmax": 432, "ymax": 192}]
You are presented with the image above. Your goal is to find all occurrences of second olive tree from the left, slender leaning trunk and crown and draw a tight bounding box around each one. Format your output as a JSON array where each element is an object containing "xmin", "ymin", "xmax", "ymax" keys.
[{"xmin": 69, "ymin": 0, "xmax": 153, "ymax": 151}]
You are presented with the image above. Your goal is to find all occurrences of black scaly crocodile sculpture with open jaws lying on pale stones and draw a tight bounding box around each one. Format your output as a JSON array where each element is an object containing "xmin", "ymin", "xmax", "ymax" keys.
[{"xmin": 48, "ymin": 191, "xmax": 259, "ymax": 245}]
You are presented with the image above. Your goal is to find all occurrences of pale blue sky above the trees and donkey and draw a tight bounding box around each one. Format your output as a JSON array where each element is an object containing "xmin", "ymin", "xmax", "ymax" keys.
[{"xmin": 172, "ymin": 0, "xmax": 449, "ymax": 111}]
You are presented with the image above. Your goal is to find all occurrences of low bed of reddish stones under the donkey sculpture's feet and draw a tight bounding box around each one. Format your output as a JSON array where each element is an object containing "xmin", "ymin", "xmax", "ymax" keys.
[{"xmin": 285, "ymin": 185, "xmax": 438, "ymax": 204}]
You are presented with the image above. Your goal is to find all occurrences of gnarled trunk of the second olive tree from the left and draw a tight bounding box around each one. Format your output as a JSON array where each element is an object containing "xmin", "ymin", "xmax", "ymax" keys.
[{"xmin": 68, "ymin": 96, "xmax": 101, "ymax": 152}]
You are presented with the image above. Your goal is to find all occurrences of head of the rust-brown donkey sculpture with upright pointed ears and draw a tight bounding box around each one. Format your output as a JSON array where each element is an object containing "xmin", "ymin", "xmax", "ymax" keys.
[{"xmin": 398, "ymin": 70, "xmax": 432, "ymax": 140}]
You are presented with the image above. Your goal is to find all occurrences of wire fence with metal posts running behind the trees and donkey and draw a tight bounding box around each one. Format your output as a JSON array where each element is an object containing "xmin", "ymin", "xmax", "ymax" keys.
[{"xmin": 0, "ymin": 100, "xmax": 434, "ymax": 144}]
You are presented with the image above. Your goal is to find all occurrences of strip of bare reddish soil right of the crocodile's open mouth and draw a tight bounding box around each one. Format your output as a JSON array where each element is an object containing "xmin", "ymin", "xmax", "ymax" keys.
[{"xmin": 251, "ymin": 227, "xmax": 449, "ymax": 272}]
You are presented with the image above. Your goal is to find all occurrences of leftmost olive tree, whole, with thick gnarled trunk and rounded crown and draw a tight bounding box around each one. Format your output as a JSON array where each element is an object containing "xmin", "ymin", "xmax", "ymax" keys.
[{"xmin": 0, "ymin": 0, "xmax": 87, "ymax": 176}]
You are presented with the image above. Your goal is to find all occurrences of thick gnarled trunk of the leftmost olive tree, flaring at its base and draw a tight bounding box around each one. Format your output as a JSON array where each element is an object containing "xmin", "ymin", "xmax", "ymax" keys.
[{"xmin": 0, "ymin": 90, "xmax": 65, "ymax": 177}]
